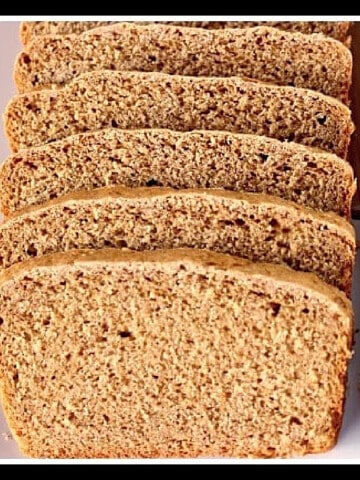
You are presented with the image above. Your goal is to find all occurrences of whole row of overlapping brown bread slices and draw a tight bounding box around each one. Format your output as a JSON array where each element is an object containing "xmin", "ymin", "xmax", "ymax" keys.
[{"xmin": 0, "ymin": 22, "xmax": 355, "ymax": 458}]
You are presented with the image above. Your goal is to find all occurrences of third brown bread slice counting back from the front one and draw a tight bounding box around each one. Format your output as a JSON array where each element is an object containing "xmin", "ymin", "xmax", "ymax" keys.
[{"xmin": 0, "ymin": 128, "xmax": 356, "ymax": 218}]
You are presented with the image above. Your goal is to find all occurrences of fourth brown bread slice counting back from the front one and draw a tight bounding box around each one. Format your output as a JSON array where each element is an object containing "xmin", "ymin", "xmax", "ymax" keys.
[{"xmin": 5, "ymin": 70, "xmax": 353, "ymax": 158}]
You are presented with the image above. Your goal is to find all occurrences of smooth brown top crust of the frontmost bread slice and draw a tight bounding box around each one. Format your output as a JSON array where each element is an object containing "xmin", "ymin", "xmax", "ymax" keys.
[{"xmin": 0, "ymin": 248, "xmax": 353, "ymax": 318}]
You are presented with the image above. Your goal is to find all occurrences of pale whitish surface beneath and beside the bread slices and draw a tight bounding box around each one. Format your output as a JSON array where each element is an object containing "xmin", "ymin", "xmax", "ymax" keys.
[{"xmin": 0, "ymin": 22, "xmax": 360, "ymax": 462}]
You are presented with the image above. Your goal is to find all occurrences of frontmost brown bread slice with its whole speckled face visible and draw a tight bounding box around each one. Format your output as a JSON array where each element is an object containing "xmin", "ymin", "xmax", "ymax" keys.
[{"xmin": 0, "ymin": 249, "xmax": 353, "ymax": 458}]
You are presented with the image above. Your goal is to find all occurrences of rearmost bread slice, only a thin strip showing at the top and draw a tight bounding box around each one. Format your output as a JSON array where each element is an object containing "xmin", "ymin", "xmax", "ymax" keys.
[{"xmin": 20, "ymin": 21, "xmax": 351, "ymax": 44}]
